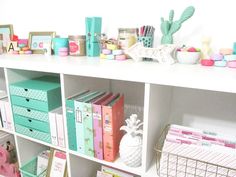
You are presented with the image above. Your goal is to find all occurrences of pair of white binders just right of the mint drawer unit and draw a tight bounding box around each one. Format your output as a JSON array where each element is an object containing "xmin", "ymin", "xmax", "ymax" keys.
[{"xmin": 48, "ymin": 107, "xmax": 65, "ymax": 147}]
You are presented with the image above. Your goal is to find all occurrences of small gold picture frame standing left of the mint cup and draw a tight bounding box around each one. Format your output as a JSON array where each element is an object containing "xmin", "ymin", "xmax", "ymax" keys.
[{"xmin": 28, "ymin": 31, "xmax": 56, "ymax": 54}]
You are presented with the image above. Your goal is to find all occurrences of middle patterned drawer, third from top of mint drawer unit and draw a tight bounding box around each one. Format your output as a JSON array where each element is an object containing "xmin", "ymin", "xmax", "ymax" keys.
[{"xmin": 12, "ymin": 105, "xmax": 49, "ymax": 122}]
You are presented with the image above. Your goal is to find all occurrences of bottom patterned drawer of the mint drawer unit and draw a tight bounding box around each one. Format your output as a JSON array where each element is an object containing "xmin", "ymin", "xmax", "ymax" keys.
[{"xmin": 15, "ymin": 124, "xmax": 51, "ymax": 143}]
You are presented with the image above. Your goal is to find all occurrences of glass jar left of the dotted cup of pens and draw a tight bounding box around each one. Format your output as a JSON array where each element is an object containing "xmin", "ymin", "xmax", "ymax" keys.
[{"xmin": 118, "ymin": 28, "xmax": 138, "ymax": 50}]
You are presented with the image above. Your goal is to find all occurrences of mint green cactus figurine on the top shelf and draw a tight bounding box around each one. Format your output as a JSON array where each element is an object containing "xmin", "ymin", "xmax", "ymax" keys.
[{"xmin": 161, "ymin": 6, "xmax": 195, "ymax": 44}]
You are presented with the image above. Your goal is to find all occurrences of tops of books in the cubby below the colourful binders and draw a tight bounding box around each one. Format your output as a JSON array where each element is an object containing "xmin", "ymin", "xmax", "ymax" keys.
[{"xmin": 96, "ymin": 166, "xmax": 134, "ymax": 177}]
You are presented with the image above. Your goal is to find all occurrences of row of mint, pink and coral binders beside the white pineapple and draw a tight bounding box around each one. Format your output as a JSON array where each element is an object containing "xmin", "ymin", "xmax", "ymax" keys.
[{"xmin": 66, "ymin": 90, "xmax": 124, "ymax": 161}]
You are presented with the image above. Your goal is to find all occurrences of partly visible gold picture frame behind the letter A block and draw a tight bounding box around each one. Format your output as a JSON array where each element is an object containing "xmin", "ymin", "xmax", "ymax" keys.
[{"xmin": 0, "ymin": 24, "xmax": 14, "ymax": 52}]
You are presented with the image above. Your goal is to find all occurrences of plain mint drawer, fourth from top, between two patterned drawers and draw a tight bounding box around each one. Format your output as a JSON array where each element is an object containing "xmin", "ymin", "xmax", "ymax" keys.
[{"xmin": 14, "ymin": 114, "xmax": 50, "ymax": 133}]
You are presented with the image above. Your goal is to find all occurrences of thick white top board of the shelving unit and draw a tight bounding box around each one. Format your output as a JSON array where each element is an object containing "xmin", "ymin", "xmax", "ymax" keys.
[{"xmin": 0, "ymin": 54, "xmax": 236, "ymax": 93}]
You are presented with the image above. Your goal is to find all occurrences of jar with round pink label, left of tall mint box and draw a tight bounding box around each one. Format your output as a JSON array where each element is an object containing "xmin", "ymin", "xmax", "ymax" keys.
[{"xmin": 69, "ymin": 35, "xmax": 86, "ymax": 56}]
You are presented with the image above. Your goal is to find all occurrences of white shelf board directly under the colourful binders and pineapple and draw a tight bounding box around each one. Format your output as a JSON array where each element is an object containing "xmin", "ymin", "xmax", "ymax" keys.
[{"xmin": 69, "ymin": 150, "xmax": 143, "ymax": 176}]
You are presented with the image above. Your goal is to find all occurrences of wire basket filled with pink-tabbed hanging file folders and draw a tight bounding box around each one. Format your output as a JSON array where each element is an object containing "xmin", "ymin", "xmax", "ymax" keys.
[{"xmin": 160, "ymin": 125, "xmax": 236, "ymax": 177}]
